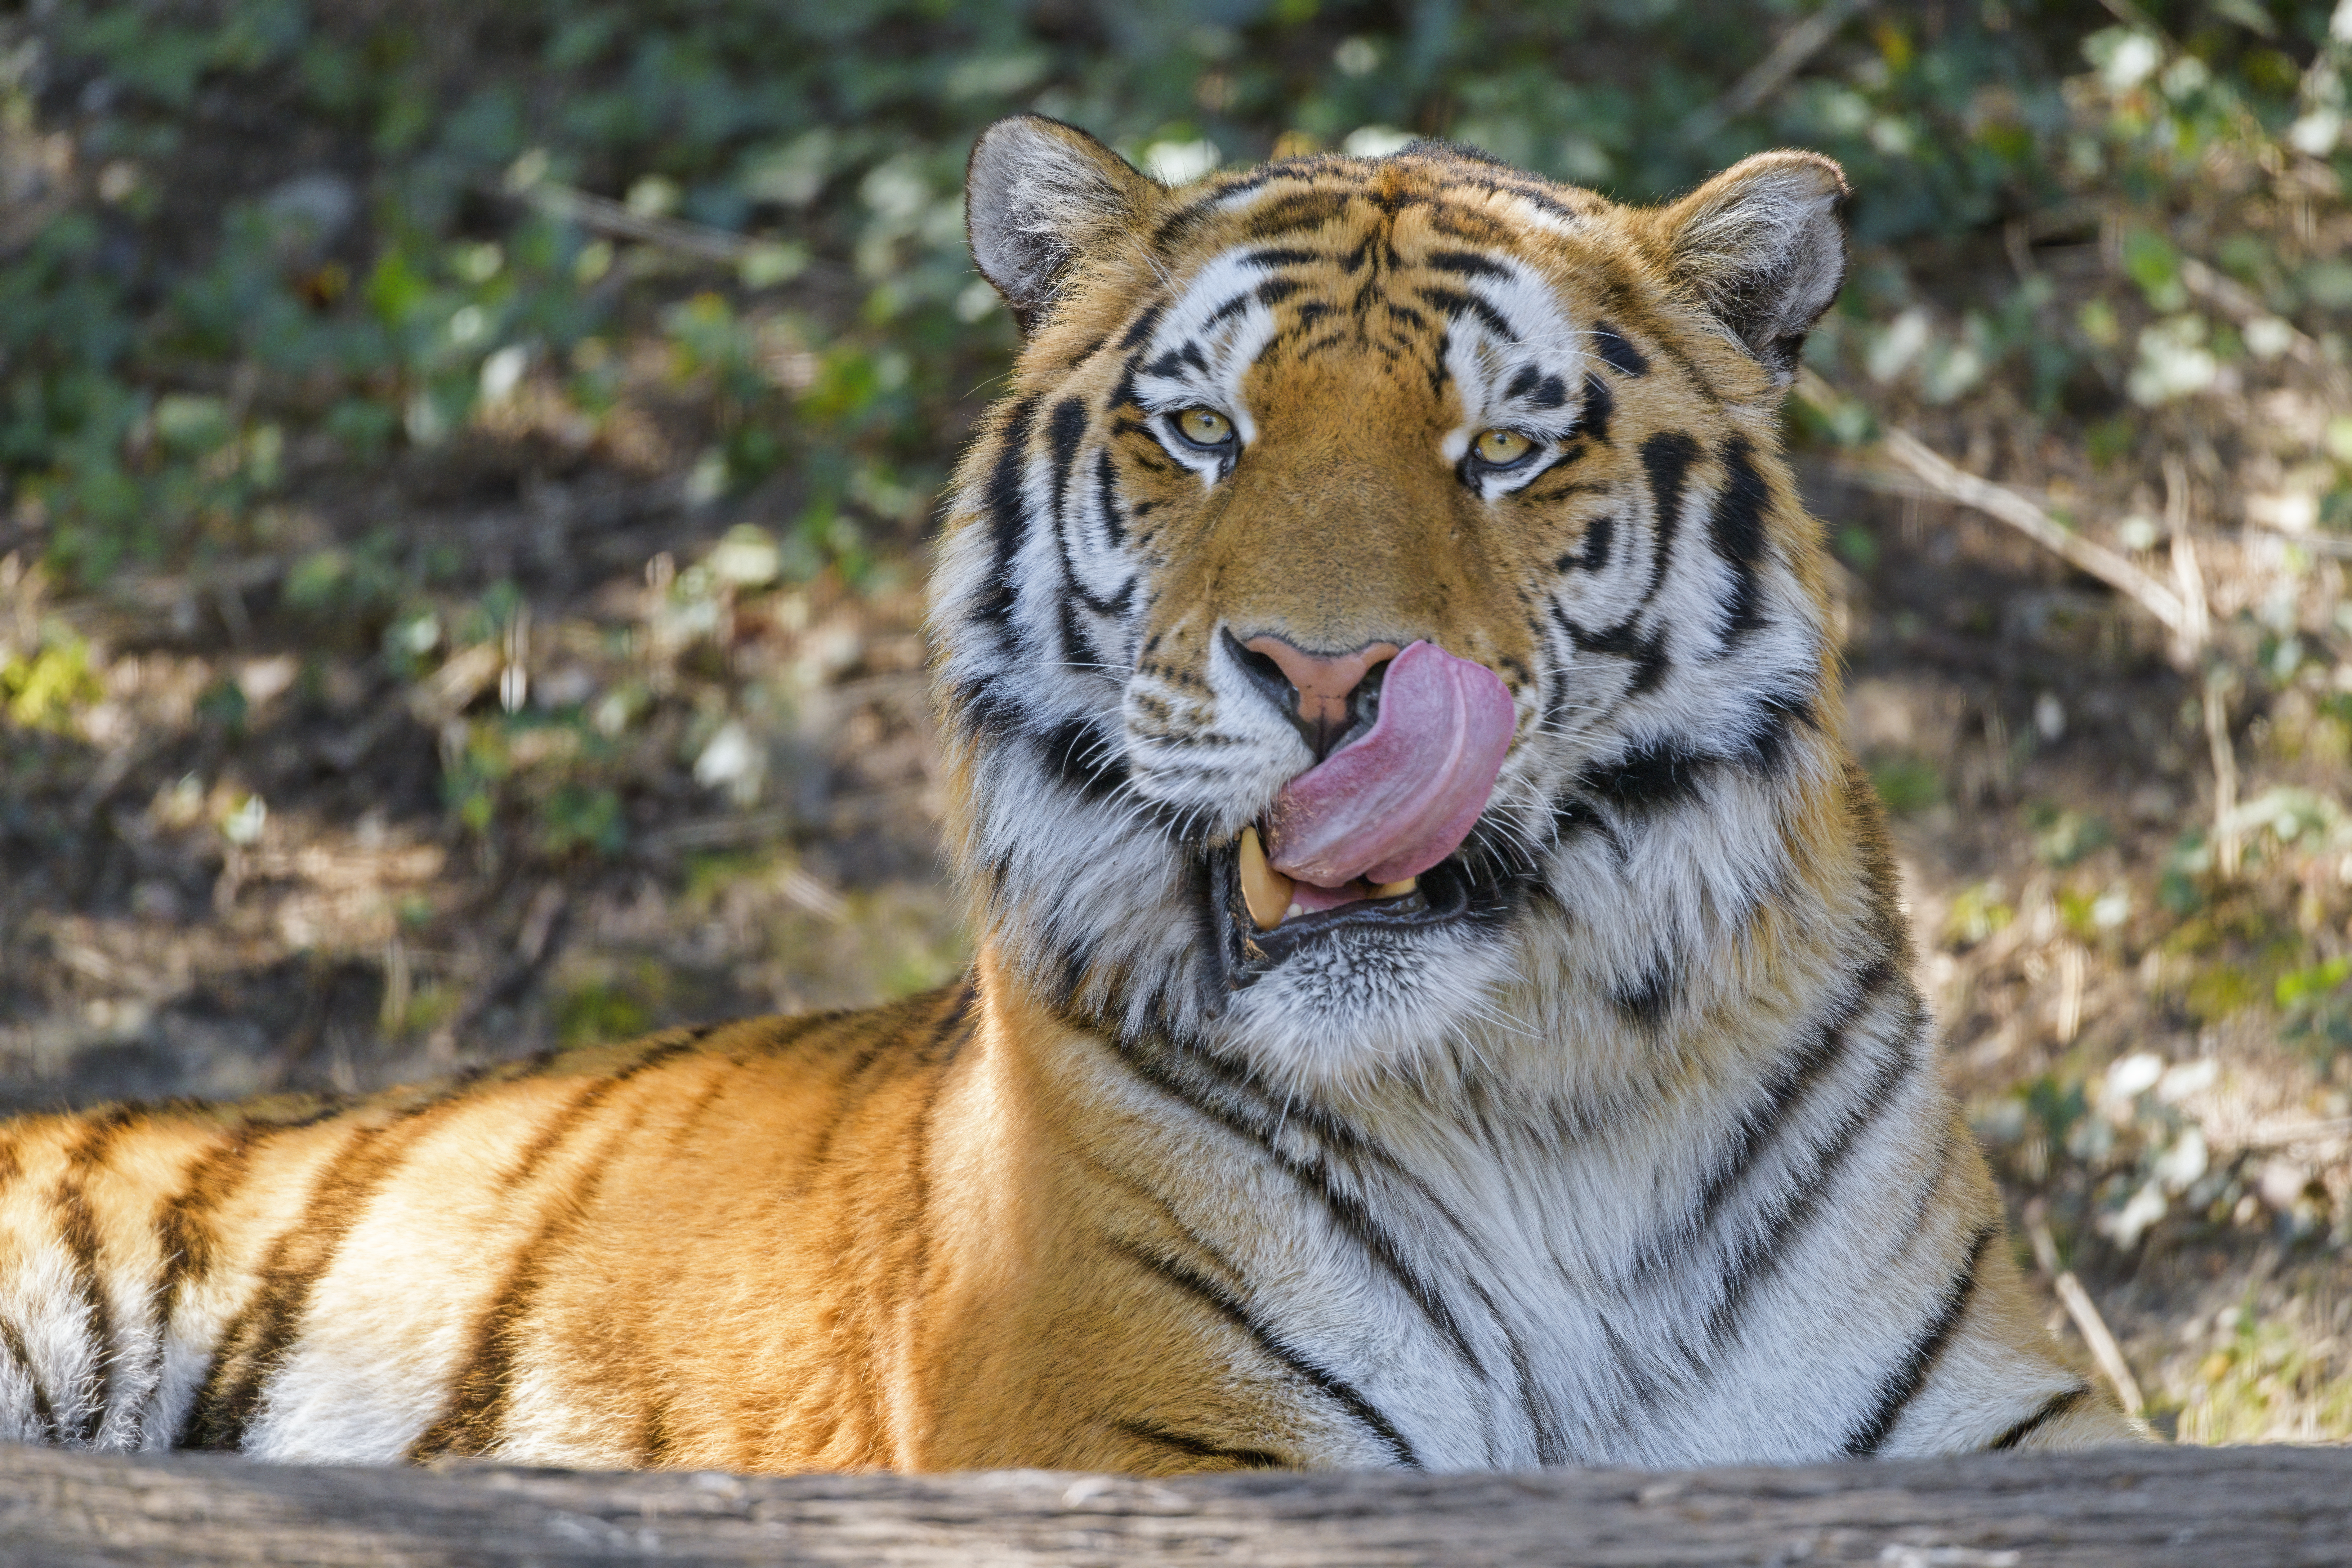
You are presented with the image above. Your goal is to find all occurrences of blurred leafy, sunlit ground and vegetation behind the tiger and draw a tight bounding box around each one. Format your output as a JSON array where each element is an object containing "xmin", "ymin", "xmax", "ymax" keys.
[{"xmin": 0, "ymin": 0, "xmax": 2352, "ymax": 1441}]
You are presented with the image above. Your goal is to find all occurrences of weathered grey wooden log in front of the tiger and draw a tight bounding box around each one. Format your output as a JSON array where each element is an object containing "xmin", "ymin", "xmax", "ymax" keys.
[{"xmin": 0, "ymin": 1446, "xmax": 2352, "ymax": 1568}]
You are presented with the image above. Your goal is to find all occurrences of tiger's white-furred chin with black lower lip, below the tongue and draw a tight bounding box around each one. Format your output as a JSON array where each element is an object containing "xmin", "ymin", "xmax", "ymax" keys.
[{"xmin": 1209, "ymin": 844, "xmax": 1510, "ymax": 1098}]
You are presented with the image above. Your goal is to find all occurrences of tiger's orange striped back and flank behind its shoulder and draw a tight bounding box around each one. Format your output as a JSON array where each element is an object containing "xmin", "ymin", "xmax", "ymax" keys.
[{"xmin": 0, "ymin": 990, "xmax": 971, "ymax": 1469}]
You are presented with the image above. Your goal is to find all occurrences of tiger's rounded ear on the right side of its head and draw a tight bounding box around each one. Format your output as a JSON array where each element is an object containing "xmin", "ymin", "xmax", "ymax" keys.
[{"xmin": 1663, "ymin": 153, "xmax": 1849, "ymax": 386}]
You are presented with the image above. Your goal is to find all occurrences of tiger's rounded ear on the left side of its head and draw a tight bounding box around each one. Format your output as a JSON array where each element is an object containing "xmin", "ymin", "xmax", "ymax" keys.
[{"xmin": 964, "ymin": 115, "xmax": 1162, "ymax": 332}]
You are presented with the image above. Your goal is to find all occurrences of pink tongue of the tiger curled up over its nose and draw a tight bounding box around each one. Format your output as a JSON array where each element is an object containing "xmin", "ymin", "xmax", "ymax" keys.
[{"xmin": 1265, "ymin": 642, "xmax": 1515, "ymax": 889}]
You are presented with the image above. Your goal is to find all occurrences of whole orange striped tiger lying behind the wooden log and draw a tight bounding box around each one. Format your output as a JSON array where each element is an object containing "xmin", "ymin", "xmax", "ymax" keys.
[{"xmin": 0, "ymin": 115, "xmax": 2145, "ymax": 1476}]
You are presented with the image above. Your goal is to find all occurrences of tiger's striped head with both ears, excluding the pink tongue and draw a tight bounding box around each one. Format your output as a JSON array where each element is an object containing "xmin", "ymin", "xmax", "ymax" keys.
[{"xmin": 931, "ymin": 115, "xmax": 1851, "ymax": 1091}]
